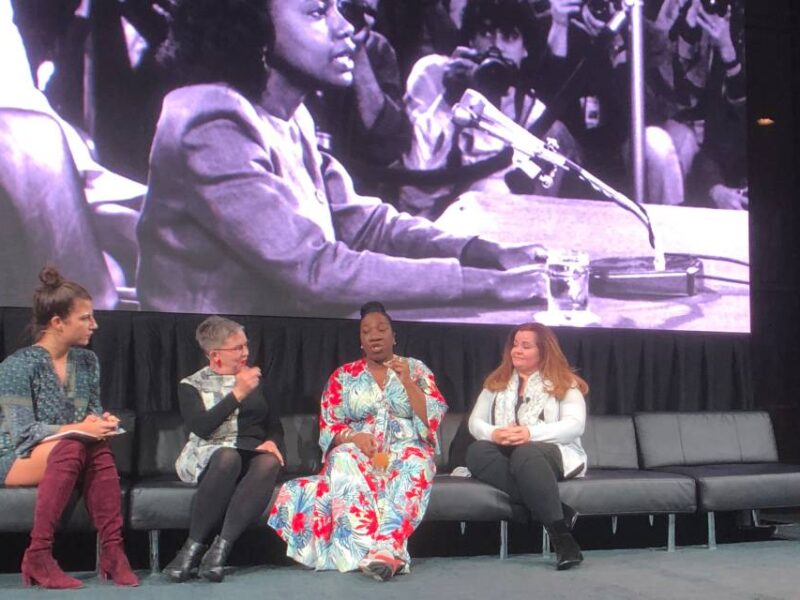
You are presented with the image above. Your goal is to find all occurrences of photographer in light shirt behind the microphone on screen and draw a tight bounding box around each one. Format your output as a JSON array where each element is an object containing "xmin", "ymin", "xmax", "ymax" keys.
[{"xmin": 400, "ymin": 0, "xmax": 579, "ymax": 216}]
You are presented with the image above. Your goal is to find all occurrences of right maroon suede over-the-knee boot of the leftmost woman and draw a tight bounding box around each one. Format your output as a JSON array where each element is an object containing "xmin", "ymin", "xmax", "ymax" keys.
[{"xmin": 83, "ymin": 442, "xmax": 139, "ymax": 586}]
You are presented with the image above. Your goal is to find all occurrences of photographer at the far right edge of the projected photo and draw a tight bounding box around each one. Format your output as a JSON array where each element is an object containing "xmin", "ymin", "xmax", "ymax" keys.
[{"xmin": 656, "ymin": 0, "xmax": 748, "ymax": 209}]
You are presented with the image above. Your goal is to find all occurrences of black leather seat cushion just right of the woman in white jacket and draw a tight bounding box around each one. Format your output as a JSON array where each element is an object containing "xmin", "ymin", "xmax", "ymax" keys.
[{"xmin": 558, "ymin": 469, "xmax": 697, "ymax": 515}]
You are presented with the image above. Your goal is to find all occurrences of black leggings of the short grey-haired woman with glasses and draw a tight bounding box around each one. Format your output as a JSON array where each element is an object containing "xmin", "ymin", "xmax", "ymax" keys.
[{"xmin": 189, "ymin": 448, "xmax": 280, "ymax": 544}]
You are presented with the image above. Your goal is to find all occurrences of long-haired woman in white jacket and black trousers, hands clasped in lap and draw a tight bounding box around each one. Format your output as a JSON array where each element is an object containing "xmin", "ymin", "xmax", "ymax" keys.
[{"xmin": 467, "ymin": 323, "xmax": 589, "ymax": 570}]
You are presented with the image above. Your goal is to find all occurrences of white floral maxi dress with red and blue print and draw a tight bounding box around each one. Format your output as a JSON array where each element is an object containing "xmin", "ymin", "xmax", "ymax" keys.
[{"xmin": 269, "ymin": 358, "xmax": 447, "ymax": 572}]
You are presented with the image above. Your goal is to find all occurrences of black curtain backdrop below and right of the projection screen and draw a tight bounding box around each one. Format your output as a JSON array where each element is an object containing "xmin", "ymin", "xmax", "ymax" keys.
[{"xmin": 0, "ymin": 0, "xmax": 800, "ymax": 462}]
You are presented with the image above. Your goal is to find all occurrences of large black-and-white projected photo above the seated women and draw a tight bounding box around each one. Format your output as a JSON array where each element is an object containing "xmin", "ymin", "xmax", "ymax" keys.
[{"xmin": 0, "ymin": 0, "xmax": 750, "ymax": 332}]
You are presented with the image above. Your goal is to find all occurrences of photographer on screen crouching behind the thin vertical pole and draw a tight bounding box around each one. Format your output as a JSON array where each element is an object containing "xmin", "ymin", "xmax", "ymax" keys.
[{"xmin": 534, "ymin": 0, "xmax": 684, "ymax": 204}]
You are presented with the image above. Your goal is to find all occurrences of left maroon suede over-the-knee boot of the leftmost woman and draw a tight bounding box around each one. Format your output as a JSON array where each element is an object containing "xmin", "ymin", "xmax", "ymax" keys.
[{"xmin": 22, "ymin": 440, "xmax": 86, "ymax": 589}]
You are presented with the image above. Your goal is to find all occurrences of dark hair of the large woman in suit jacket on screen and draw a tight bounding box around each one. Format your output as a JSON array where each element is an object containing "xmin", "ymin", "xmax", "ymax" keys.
[{"xmin": 158, "ymin": 0, "xmax": 275, "ymax": 99}]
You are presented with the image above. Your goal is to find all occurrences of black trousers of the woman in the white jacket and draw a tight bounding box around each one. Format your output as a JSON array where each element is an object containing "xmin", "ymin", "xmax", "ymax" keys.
[{"xmin": 467, "ymin": 440, "xmax": 564, "ymax": 525}]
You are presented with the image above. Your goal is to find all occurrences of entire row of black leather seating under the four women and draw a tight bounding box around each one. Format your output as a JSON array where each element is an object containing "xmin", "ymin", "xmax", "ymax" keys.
[{"xmin": 0, "ymin": 412, "xmax": 800, "ymax": 572}]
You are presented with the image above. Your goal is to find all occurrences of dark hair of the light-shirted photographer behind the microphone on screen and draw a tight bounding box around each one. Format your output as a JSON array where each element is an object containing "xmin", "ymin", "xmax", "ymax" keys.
[{"xmin": 461, "ymin": 0, "xmax": 535, "ymax": 52}]
